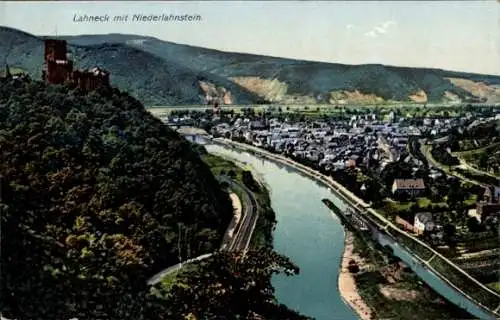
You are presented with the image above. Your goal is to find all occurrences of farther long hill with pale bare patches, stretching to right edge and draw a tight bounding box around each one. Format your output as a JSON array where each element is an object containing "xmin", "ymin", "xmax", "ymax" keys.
[{"xmin": 59, "ymin": 34, "xmax": 500, "ymax": 103}]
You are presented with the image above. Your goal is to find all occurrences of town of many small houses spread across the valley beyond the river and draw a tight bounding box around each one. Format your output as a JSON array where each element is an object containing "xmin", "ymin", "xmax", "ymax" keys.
[{"xmin": 158, "ymin": 106, "xmax": 500, "ymax": 296}]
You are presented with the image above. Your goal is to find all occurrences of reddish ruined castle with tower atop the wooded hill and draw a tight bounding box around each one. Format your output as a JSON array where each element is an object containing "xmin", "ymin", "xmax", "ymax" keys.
[{"xmin": 42, "ymin": 39, "xmax": 109, "ymax": 91}]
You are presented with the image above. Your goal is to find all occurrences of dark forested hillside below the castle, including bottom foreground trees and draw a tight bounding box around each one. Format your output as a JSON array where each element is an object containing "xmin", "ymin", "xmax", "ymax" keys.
[{"xmin": 0, "ymin": 78, "xmax": 306, "ymax": 320}]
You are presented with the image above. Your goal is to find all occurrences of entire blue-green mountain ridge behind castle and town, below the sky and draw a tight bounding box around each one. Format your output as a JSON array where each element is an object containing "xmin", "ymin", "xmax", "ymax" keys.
[{"xmin": 0, "ymin": 27, "xmax": 500, "ymax": 105}]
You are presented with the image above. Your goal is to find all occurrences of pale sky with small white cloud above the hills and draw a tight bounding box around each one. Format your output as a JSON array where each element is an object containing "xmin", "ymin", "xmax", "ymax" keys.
[{"xmin": 0, "ymin": 0, "xmax": 500, "ymax": 75}]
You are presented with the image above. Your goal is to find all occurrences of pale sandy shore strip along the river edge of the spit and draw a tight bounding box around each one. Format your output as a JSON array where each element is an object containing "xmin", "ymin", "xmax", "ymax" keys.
[{"xmin": 338, "ymin": 230, "xmax": 373, "ymax": 320}]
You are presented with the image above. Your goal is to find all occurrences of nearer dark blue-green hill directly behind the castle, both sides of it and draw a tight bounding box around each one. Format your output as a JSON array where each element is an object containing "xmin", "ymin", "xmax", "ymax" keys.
[{"xmin": 0, "ymin": 27, "xmax": 258, "ymax": 105}]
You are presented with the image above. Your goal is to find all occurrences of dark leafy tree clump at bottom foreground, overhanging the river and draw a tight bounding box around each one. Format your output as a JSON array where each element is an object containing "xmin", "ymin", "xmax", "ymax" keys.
[{"xmin": 155, "ymin": 249, "xmax": 309, "ymax": 320}]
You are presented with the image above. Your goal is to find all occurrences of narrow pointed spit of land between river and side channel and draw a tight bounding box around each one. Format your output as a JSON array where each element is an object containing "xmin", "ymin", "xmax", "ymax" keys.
[{"xmin": 323, "ymin": 199, "xmax": 472, "ymax": 320}]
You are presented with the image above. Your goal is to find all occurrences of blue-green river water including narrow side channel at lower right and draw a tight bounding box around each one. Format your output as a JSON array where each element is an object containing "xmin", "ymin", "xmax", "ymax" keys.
[{"xmin": 206, "ymin": 141, "xmax": 496, "ymax": 320}]
